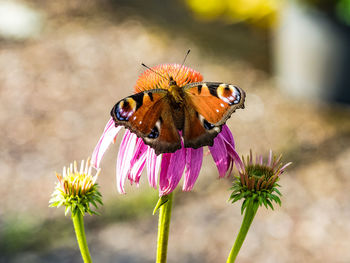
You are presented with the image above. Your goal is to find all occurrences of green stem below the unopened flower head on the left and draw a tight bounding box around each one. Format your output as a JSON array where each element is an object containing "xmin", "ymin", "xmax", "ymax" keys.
[{"xmin": 72, "ymin": 212, "xmax": 92, "ymax": 263}]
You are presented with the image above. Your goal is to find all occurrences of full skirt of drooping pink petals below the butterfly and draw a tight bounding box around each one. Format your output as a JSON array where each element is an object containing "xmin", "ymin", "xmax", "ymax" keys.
[{"xmin": 92, "ymin": 118, "xmax": 240, "ymax": 196}]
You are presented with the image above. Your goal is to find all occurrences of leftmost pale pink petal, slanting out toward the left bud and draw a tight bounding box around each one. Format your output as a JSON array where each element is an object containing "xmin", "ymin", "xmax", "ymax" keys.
[{"xmin": 91, "ymin": 118, "xmax": 121, "ymax": 169}]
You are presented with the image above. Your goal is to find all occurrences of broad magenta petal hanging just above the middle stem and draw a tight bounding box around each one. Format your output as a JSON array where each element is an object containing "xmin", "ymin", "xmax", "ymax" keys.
[{"xmin": 159, "ymin": 148, "xmax": 186, "ymax": 196}]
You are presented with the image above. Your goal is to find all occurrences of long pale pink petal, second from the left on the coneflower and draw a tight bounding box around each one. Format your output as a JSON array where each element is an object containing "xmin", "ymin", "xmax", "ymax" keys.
[{"xmin": 117, "ymin": 130, "xmax": 137, "ymax": 194}]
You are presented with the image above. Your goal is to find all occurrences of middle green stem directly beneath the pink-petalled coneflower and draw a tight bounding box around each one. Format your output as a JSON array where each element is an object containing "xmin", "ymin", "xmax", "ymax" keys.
[{"xmin": 156, "ymin": 193, "xmax": 173, "ymax": 263}]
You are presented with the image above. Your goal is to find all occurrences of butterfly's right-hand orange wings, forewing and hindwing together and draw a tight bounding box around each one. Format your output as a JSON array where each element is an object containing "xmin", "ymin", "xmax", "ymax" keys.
[{"xmin": 183, "ymin": 82, "xmax": 245, "ymax": 148}]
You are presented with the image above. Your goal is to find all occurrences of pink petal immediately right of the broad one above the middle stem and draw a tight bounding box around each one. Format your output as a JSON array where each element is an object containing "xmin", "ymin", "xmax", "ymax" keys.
[{"xmin": 182, "ymin": 147, "xmax": 203, "ymax": 191}]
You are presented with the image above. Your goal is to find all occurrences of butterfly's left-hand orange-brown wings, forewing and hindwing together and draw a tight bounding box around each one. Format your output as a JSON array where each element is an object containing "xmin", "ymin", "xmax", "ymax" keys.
[{"xmin": 111, "ymin": 89, "xmax": 181, "ymax": 154}]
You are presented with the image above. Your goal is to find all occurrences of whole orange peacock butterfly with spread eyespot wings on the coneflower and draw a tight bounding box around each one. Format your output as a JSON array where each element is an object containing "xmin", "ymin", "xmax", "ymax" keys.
[{"xmin": 111, "ymin": 77, "xmax": 245, "ymax": 154}]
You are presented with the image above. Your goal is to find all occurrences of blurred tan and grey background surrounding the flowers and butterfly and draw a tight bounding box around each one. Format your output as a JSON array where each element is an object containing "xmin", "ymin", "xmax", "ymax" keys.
[{"xmin": 0, "ymin": 0, "xmax": 350, "ymax": 263}]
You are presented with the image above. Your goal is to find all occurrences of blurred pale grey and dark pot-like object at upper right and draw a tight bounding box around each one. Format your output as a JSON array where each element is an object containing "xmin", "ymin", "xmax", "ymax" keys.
[{"xmin": 274, "ymin": 1, "xmax": 350, "ymax": 103}]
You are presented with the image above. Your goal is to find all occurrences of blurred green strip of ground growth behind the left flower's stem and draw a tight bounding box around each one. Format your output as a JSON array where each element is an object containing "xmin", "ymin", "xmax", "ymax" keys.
[{"xmin": 0, "ymin": 189, "xmax": 158, "ymax": 262}]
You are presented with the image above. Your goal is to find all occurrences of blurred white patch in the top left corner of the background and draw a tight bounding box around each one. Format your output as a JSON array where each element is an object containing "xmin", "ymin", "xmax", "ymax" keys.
[{"xmin": 0, "ymin": 1, "xmax": 42, "ymax": 40}]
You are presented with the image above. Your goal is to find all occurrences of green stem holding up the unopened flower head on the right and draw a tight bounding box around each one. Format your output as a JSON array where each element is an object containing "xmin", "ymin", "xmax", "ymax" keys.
[{"xmin": 226, "ymin": 200, "xmax": 259, "ymax": 263}]
